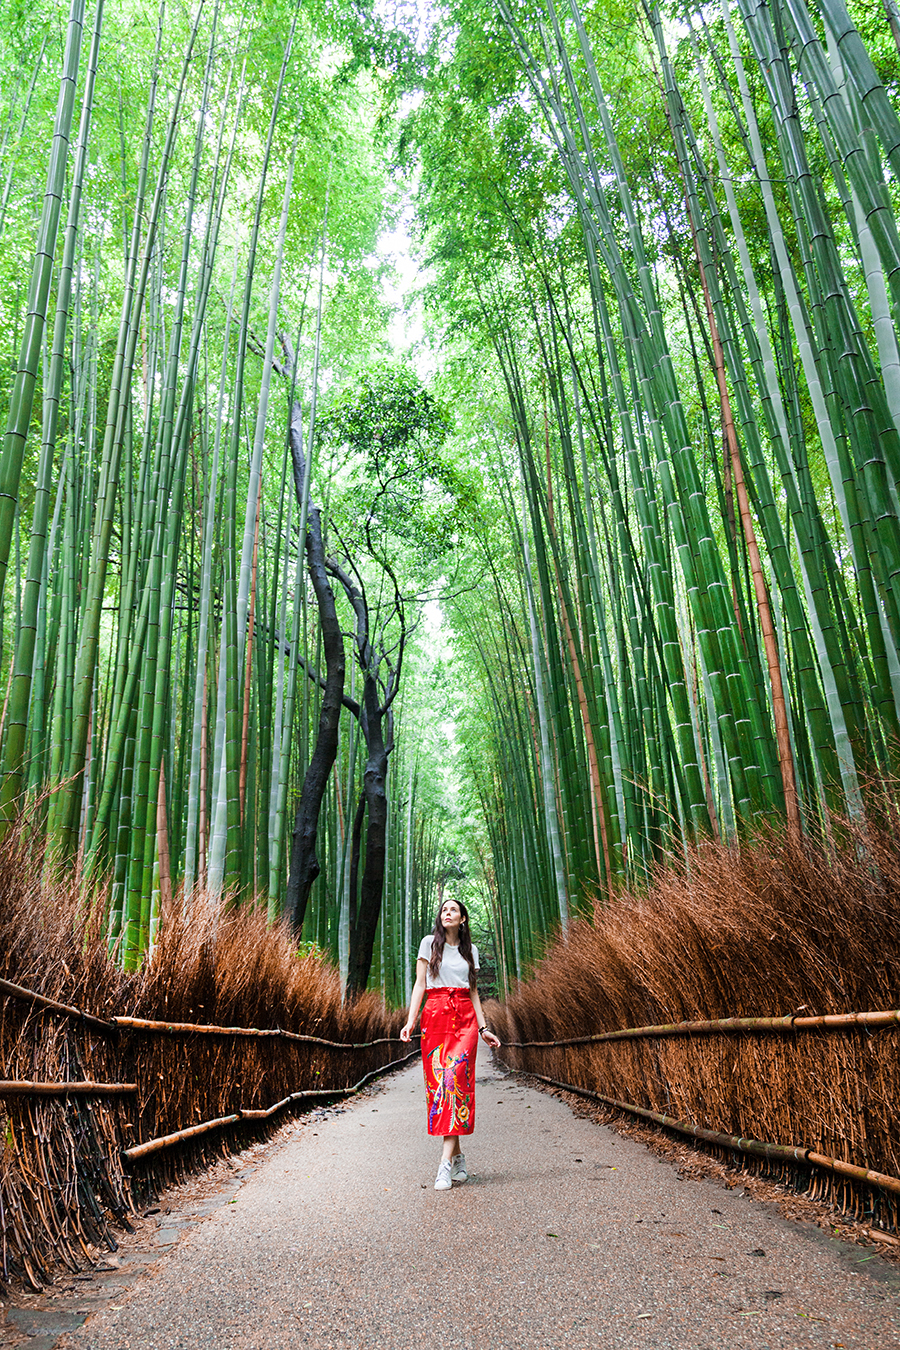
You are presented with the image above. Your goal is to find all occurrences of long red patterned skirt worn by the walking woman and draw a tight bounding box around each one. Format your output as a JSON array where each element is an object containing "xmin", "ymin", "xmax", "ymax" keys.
[{"xmin": 422, "ymin": 988, "xmax": 478, "ymax": 1134}]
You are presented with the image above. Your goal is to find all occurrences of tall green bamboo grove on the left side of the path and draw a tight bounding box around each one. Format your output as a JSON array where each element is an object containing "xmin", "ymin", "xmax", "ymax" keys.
[{"xmin": 0, "ymin": 0, "xmax": 458, "ymax": 999}]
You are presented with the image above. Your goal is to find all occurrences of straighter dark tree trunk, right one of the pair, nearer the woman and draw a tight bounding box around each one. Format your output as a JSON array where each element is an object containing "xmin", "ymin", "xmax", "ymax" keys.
[{"xmin": 347, "ymin": 675, "xmax": 390, "ymax": 996}]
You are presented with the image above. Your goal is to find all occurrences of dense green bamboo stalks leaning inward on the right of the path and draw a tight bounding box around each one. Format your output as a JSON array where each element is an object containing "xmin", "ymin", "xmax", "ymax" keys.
[{"xmin": 414, "ymin": 0, "xmax": 900, "ymax": 975}]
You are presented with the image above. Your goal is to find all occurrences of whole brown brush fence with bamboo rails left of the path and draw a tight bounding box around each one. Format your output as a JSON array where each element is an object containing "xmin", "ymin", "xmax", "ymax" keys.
[{"xmin": 0, "ymin": 837, "xmax": 409, "ymax": 1288}]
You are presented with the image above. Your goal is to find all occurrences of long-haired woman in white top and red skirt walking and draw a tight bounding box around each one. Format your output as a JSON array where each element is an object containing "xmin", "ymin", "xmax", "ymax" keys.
[{"xmin": 399, "ymin": 900, "xmax": 501, "ymax": 1191}]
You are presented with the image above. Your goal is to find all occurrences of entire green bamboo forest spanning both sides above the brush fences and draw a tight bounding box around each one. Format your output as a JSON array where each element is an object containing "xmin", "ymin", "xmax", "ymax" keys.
[{"xmin": 0, "ymin": 0, "xmax": 900, "ymax": 999}]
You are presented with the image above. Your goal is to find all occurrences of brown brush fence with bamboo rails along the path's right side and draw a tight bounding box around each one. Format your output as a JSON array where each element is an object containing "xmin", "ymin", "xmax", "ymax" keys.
[{"xmin": 490, "ymin": 810, "xmax": 900, "ymax": 1231}]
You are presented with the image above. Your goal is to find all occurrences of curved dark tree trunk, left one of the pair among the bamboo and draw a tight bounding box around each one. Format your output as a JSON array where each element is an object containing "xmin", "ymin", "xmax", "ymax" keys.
[{"xmin": 285, "ymin": 404, "xmax": 345, "ymax": 937}]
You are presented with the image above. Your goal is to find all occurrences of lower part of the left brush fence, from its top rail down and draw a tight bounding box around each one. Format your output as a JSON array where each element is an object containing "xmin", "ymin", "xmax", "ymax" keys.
[{"xmin": 0, "ymin": 980, "xmax": 417, "ymax": 1287}]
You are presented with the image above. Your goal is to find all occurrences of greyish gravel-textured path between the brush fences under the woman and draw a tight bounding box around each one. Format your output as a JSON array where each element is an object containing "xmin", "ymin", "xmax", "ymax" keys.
[{"xmin": 65, "ymin": 1064, "xmax": 900, "ymax": 1350}]
